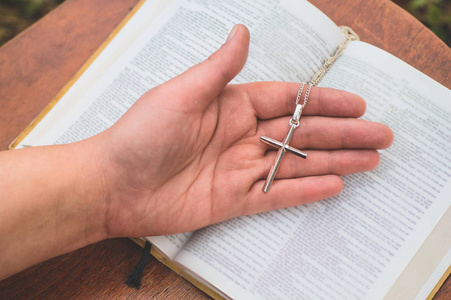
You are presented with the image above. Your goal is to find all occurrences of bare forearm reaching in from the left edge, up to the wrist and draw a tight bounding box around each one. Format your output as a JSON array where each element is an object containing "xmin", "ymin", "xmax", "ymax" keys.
[{"xmin": 0, "ymin": 141, "xmax": 105, "ymax": 279}]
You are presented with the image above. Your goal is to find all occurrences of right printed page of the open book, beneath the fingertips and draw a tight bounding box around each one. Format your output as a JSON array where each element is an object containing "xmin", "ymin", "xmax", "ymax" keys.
[{"xmin": 176, "ymin": 42, "xmax": 451, "ymax": 299}]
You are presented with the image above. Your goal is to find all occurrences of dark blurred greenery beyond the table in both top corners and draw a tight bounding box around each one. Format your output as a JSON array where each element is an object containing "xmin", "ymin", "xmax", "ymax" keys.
[{"xmin": 0, "ymin": 0, "xmax": 451, "ymax": 46}]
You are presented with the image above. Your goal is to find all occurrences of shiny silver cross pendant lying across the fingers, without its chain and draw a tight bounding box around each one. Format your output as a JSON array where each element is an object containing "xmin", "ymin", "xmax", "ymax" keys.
[{"xmin": 260, "ymin": 104, "xmax": 307, "ymax": 193}]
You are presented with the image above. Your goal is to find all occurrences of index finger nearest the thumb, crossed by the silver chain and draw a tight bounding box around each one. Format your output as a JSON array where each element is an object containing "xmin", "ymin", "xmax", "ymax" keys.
[{"xmin": 245, "ymin": 82, "xmax": 366, "ymax": 119}]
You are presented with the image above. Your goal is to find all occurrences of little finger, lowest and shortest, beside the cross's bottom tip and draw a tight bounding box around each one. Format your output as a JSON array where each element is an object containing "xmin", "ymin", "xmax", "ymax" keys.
[{"xmin": 242, "ymin": 175, "xmax": 343, "ymax": 215}]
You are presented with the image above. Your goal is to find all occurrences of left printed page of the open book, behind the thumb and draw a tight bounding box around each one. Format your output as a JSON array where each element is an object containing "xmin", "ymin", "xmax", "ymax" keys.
[{"xmin": 15, "ymin": 0, "xmax": 344, "ymax": 256}]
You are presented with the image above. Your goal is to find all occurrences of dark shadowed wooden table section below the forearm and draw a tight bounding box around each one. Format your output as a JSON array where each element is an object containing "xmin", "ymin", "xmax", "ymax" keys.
[{"xmin": 0, "ymin": 239, "xmax": 208, "ymax": 299}]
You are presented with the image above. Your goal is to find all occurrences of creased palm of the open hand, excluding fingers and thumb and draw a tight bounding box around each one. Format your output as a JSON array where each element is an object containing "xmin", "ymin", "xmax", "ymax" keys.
[{"xmin": 103, "ymin": 82, "xmax": 265, "ymax": 235}]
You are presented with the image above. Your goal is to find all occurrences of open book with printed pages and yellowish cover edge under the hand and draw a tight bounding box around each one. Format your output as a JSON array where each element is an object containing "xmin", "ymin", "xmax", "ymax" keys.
[{"xmin": 11, "ymin": 0, "xmax": 451, "ymax": 299}]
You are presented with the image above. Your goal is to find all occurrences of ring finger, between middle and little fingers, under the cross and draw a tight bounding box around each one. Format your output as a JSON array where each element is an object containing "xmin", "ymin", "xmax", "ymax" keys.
[{"xmin": 259, "ymin": 150, "xmax": 380, "ymax": 179}]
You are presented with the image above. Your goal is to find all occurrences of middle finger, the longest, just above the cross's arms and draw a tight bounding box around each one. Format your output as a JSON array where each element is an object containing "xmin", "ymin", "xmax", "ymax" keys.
[{"xmin": 257, "ymin": 116, "xmax": 393, "ymax": 149}]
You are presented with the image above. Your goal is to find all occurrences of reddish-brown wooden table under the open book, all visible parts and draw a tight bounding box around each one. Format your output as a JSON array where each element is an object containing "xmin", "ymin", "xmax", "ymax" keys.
[{"xmin": 0, "ymin": 0, "xmax": 451, "ymax": 300}]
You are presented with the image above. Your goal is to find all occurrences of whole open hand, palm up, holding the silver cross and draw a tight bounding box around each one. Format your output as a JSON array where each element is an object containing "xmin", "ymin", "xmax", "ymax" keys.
[{"xmin": 94, "ymin": 25, "xmax": 393, "ymax": 237}]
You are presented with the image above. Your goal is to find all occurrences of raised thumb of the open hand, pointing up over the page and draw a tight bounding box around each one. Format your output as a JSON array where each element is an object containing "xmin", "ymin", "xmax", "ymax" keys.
[{"xmin": 153, "ymin": 24, "xmax": 249, "ymax": 111}]
